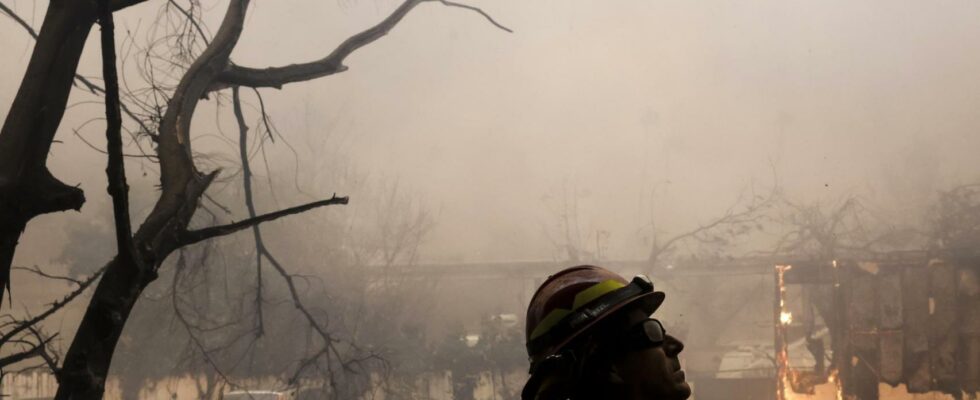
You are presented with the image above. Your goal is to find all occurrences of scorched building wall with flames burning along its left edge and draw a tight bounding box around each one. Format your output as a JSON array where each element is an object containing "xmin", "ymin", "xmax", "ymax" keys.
[{"xmin": 774, "ymin": 252, "xmax": 980, "ymax": 400}]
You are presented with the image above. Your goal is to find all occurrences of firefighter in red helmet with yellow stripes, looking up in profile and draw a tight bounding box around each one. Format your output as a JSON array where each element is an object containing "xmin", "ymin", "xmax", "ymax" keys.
[{"xmin": 521, "ymin": 265, "xmax": 691, "ymax": 400}]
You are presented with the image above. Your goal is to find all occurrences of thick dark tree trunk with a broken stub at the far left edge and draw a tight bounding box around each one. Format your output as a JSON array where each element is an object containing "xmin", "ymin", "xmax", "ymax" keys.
[{"xmin": 0, "ymin": 0, "xmax": 96, "ymax": 306}]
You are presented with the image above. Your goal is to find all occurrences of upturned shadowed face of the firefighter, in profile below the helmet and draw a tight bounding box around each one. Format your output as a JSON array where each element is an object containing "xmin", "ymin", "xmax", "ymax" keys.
[{"xmin": 613, "ymin": 309, "xmax": 691, "ymax": 400}]
